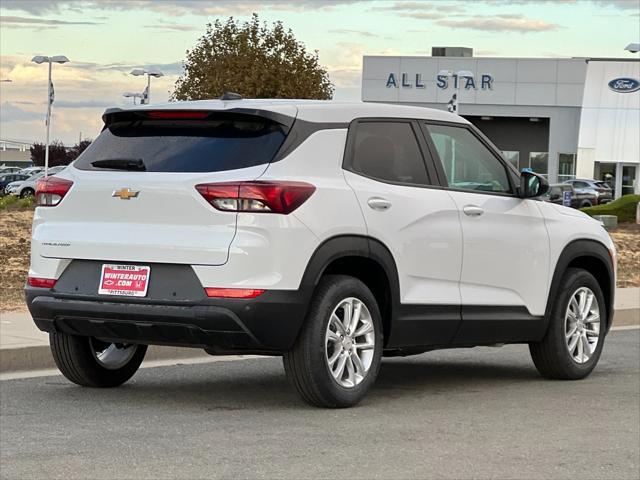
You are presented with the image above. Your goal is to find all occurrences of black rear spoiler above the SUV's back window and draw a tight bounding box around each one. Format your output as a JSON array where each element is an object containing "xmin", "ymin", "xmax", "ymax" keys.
[{"xmin": 102, "ymin": 108, "xmax": 296, "ymax": 132}]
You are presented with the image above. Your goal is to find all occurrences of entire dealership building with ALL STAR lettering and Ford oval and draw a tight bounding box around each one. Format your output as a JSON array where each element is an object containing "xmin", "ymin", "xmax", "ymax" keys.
[{"xmin": 362, "ymin": 47, "xmax": 640, "ymax": 197}]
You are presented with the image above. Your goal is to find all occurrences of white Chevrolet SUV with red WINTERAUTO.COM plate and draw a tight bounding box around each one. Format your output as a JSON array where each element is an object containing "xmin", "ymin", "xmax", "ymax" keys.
[{"xmin": 26, "ymin": 100, "xmax": 615, "ymax": 407}]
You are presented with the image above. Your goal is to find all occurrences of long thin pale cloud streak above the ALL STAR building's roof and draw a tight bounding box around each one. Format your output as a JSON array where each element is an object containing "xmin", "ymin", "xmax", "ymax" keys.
[{"xmin": 436, "ymin": 14, "xmax": 561, "ymax": 33}]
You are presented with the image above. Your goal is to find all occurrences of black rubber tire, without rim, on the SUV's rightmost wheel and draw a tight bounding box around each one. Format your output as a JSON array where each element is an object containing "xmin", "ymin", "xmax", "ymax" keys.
[{"xmin": 529, "ymin": 268, "xmax": 607, "ymax": 380}]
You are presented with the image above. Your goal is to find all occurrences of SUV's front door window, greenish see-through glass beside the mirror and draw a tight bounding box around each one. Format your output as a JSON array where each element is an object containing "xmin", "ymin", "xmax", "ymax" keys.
[{"xmin": 427, "ymin": 125, "xmax": 511, "ymax": 193}]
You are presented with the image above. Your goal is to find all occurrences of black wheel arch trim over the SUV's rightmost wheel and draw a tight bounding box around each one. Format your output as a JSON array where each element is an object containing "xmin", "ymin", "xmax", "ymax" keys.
[{"xmin": 544, "ymin": 239, "xmax": 616, "ymax": 332}]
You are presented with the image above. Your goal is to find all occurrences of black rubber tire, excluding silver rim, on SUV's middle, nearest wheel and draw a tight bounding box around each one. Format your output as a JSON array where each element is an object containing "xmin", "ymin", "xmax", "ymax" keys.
[{"xmin": 283, "ymin": 275, "xmax": 383, "ymax": 408}]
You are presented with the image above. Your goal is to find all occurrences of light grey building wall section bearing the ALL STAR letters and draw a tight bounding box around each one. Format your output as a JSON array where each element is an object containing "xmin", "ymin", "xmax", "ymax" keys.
[{"xmin": 362, "ymin": 56, "xmax": 587, "ymax": 182}]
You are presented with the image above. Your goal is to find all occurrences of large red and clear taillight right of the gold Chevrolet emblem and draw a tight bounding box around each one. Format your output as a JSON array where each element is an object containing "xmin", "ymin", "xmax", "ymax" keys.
[{"xmin": 196, "ymin": 181, "xmax": 316, "ymax": 215}]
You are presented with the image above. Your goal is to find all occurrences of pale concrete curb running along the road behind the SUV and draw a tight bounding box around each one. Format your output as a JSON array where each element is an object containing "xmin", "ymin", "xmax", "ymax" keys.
[{"xmin": 0, "ymin": 308, "xmax": 640, "ymax": 373}]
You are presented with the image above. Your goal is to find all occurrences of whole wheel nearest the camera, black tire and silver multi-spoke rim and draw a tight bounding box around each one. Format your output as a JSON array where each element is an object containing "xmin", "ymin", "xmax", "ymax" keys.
[{"xmin": 283, "ymin": 275, "xmax": 382, "ymax": 408}]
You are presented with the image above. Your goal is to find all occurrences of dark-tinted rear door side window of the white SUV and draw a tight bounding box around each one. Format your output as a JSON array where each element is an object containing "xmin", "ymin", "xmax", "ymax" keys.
[{"xmin": 351, "ymin": 122, "xmax": 428, "ymax": 185}]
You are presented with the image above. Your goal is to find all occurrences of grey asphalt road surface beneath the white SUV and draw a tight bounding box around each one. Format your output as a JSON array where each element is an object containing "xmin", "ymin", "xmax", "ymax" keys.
[{"xmin": 0, "ymin": 329, "xmax": 640, "ymax": 479}]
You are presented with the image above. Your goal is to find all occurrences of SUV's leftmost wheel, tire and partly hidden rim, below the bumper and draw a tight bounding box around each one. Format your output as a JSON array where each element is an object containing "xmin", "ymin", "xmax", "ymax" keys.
[{"xmin": 49, "ymin": 333, "xmax": 147, "ymax": 387}]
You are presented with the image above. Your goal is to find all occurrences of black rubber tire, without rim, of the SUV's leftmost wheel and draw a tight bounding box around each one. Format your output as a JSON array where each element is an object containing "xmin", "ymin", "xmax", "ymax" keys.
[{"xmin": 49, "ymin": 333, "xmax": 147, "ymax": 388}]
